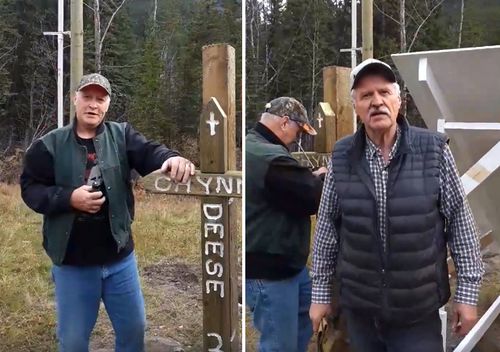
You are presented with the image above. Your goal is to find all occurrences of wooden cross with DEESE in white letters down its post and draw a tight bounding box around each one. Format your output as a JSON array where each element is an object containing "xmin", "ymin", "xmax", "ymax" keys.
[{"xmin": 144, "ymin": 44, "xmax": 242, "ymax": 352}]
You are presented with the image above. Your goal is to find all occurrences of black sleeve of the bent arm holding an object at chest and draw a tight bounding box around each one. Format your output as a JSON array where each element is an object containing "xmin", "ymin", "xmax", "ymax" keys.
[{"xmin": 20, "ymin": 140, "xmax": 74, "ymax": 215}]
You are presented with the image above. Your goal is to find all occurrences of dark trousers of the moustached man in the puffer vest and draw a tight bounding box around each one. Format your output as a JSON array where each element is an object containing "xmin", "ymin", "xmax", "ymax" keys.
[{"xmin": 342, "ymin": 309, "xmax": 443, "ymax": 352}]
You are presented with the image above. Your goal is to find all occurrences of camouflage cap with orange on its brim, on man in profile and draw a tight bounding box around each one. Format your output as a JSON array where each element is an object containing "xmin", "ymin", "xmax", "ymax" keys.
[{"xmin": 265, "ymin": 97, "xmax": 317, "ymax": 136}]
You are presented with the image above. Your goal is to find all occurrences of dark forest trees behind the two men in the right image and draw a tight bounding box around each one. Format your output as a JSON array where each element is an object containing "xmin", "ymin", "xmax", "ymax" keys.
[{"xmin": 246, "ymin": 0, "xmax": 500, "ymax": 132}]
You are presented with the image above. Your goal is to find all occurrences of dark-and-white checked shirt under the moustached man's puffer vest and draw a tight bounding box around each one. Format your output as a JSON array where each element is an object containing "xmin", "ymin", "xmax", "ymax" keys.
[{"xmin": 312, "ymin": 129, "xmax": 484, "ymax": 305}]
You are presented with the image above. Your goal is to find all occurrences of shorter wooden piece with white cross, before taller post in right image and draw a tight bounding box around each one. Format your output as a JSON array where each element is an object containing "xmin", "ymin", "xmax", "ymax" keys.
[{"xmin": 314, "ymin": 103, "xmax": 337, "ymax": 153}]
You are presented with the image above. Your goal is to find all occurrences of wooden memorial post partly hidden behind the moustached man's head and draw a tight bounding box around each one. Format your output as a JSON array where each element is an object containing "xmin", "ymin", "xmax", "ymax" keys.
[{"xmin": 293, "ymin": 66, "xmax": 356, "ymax": 167}]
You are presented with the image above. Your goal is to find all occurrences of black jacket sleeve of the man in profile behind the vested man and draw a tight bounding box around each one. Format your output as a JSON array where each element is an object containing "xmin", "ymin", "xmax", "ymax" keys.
[{"xmin": 265, "ymin": 157, "xmax": 323, "ymax": 216}]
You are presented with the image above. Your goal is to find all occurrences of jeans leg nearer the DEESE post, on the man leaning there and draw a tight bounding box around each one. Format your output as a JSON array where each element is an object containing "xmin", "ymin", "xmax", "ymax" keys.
[{"xmin": 103, "ymin": 253, "xmax": 146, "ymax": 352}]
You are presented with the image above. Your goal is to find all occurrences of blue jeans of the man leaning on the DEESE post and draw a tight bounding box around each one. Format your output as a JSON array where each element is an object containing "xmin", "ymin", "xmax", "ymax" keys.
[{"xmin": 52, "ymin": 252, "xmax": 146, "ymax": 352}]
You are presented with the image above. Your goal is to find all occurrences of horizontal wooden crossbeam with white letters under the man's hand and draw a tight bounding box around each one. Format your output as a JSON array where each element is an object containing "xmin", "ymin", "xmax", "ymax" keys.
[{"xmin": 140, "ymin": 170, "xmax": 243, "ymax": 198}]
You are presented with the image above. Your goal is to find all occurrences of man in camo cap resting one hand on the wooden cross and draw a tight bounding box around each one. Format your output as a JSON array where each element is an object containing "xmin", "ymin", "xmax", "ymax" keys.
[{"xmin": 21, "ymin": 73, "xmax": 194, "ymax": 352}]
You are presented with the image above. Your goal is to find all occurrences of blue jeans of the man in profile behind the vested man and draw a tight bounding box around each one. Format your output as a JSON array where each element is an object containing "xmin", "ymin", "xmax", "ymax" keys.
[{"xmin": 245, "ymin": 268, "xmax": 312, "ymax": 352}]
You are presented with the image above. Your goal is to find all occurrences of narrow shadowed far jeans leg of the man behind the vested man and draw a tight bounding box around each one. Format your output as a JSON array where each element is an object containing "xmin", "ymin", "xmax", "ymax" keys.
[{"xmin": 297, "ymin": 268, "xmax": 313, "ymax": 352}]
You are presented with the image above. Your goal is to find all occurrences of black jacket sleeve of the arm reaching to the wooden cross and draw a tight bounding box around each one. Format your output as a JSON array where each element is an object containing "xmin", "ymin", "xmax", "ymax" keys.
[{"xmin": 125, "ymin": 123, "xmax": 179, "ymax": 176}]
